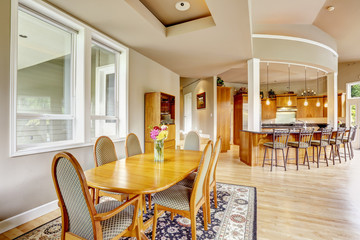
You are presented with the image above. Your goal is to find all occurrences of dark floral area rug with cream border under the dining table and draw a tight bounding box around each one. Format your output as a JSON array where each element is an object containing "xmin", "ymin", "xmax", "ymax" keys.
[{"xmin": 15, "ymin": 183, "xmax": 256, "ymax": 240}]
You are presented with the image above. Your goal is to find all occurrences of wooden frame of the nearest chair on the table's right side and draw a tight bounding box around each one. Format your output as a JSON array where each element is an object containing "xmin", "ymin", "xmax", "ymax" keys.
[{"xmin": 152, "ymin": 141, "xmax": 214, "ymax": 240}]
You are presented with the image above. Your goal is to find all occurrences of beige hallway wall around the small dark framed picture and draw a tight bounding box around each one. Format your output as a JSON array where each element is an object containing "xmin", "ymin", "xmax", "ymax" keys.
[{"xmin": 181, "ymin": 77, "xmax": 215, "ymax": 139}]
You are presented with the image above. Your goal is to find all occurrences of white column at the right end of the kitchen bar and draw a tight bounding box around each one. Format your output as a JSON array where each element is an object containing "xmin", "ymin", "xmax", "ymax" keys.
[{"xmin": 327, "ymin": 72, "xmax": 338, "ymax": 130}]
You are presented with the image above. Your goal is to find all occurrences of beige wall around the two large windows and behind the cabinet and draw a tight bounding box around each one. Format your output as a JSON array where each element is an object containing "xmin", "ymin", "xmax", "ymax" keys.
[{"xmin": 0, "ymin": 0, "xmax": 179, "ymax": 221}]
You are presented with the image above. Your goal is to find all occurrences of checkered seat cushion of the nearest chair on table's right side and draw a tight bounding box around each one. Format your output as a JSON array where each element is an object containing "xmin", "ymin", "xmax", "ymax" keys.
[{"xmin": 152, "ymin": 185, "xmax": 191, "ymax": 211}]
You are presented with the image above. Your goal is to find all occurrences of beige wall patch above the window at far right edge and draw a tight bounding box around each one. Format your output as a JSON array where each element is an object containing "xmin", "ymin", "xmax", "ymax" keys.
[{"xmin": 338, "ymin": 61, "xmax": 360, "ymax": 93}]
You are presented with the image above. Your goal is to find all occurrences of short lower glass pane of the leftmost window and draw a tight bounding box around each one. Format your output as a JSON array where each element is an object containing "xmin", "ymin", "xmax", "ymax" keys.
[{"xmin": 16, "ymin": 119, "xmax": 73, "ymax": 146}]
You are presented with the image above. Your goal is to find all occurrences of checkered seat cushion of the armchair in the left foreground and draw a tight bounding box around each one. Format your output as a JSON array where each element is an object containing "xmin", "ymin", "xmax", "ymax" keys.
[{"xmin": 95, "ymin": 201, "xmax": 134, "ymax": 240}]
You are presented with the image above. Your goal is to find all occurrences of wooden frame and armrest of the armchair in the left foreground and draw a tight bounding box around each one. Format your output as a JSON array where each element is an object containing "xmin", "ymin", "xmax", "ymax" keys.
[{"xmin": 51, "ymin": 152, "xmax": 140, "ymax": 240}]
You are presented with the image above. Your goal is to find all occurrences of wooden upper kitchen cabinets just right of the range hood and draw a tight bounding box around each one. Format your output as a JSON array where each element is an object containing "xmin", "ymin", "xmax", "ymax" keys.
[{"xmin": 296, "ymin": 96, "xmax": 324, "ymax": 118}]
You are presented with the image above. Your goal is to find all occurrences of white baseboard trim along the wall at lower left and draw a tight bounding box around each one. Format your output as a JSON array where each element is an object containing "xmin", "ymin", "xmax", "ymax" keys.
[{"xmin": 0, "ymin": 200, "xmax": 59, "ymax": 233}]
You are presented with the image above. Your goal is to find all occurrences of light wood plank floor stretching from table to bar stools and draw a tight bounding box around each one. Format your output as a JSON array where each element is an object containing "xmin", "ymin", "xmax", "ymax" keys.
[{"xmin": 0, "ymin": 146, "xmax": 360, "ymax": 240}]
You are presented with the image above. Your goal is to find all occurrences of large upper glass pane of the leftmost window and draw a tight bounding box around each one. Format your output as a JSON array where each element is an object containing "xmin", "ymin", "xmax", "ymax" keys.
[{"xmin": 17, "ymin": 11, "xmax": 73, "ymax": 114}]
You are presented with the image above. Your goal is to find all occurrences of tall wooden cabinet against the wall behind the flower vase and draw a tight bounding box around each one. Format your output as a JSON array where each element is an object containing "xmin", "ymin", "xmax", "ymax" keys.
[{"xmin": 144, "ymin": 92, "xmax": 176, "ymax": 153}]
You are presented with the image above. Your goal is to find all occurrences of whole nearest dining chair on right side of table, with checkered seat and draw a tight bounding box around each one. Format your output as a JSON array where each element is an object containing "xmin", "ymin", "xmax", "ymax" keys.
[{"xmin": 152, "ymin": 141, "xmax": 214, "ymax": 240}]
